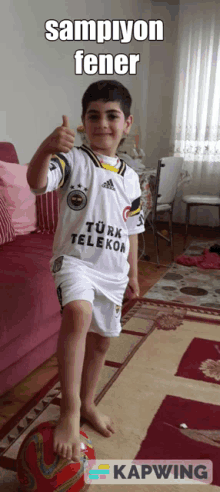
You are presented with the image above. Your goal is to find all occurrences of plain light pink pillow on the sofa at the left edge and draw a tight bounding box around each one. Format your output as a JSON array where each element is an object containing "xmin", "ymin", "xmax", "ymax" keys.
[{"xmin": 0, "ymin": 161, "xmax": 37, "ymax": 235}]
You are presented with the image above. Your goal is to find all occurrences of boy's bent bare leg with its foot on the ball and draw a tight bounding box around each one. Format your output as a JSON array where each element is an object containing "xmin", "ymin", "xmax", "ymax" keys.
[{"xmin": 54, "ymin": 300, "xmax": 92, "ymax": 461}]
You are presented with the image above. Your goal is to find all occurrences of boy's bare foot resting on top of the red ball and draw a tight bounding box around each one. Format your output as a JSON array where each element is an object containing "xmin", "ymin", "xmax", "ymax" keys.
[{"xmin": 54, "ymin": 412, "xmax": 81, "ymax": 461}]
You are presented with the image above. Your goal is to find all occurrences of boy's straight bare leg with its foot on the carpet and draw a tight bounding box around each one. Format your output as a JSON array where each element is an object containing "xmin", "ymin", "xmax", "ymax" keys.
[{"xmin": 80, "ymin": 332, "xmax": 114, "ymax": 437}]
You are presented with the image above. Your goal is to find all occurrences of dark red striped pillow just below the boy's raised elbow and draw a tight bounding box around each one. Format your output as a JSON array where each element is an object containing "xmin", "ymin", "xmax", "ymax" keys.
[{"xmin": 36, "ymin": 190, "xmax": 59, "ymax": 234}]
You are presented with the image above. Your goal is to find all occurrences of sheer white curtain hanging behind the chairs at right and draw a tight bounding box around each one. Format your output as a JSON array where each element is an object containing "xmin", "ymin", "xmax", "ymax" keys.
[{"xmin": 171, "ymin": 0, "xmax": 220, "ymax": 226}]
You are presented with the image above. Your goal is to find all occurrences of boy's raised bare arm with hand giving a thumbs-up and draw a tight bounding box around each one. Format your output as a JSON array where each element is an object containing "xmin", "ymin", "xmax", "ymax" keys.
[{"xmin": 27, "ymin": 116, "xmax": 75, "ymax": 190}]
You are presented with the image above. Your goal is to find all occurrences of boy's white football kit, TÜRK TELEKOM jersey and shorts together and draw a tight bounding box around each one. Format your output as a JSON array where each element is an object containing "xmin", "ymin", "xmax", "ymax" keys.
[{"xmin": 32, "ymin": 145, "xmax": 145, "ymax": 336}]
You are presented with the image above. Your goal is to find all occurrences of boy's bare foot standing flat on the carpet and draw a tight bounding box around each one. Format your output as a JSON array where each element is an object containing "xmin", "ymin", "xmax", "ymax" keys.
[{"xmin": 81, "ymin": 404, "xmax": 115, "ymax": 437}]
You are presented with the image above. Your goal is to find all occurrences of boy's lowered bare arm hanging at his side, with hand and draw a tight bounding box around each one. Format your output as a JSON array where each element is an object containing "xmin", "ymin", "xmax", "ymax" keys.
[{"xmin": 128, "ymin": 234, "xmax": 140, "ymax": 298}]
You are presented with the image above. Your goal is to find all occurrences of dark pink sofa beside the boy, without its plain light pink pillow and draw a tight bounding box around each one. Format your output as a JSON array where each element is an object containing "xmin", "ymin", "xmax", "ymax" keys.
[{"xmin": 0, "ymin": 142, "xmax": 61, "ymax": 394}]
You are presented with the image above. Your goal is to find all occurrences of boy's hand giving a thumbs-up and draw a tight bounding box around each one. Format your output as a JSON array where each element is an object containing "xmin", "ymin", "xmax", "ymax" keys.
[{"xmin": 43, "ymin": 116, "xmax": 75, "ymax": 154}]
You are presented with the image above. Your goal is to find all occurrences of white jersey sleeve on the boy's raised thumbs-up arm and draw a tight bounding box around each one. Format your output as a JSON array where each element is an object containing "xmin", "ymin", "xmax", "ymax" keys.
[{"xmin": 31, "ymin": 152, "xmax": 73, "ymax": 195}]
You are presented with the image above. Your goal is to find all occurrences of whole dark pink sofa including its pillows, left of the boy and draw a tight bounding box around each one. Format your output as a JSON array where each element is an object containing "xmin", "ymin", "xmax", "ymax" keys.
[{"xmin": 0, "ymin": 142, "xmax": 61, "ymax": 394}]
